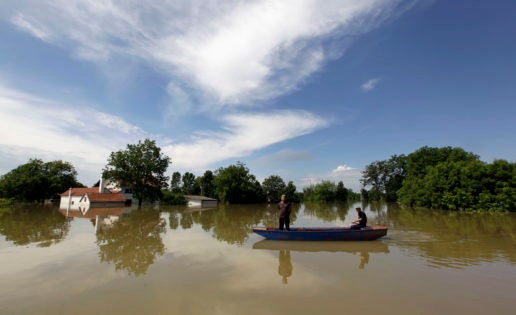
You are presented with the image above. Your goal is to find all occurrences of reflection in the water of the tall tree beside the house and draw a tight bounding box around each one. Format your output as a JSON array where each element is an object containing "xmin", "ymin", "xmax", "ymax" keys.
[{"xmin": 97, "ymin": 208, "xmax": 166, "ymax": 276}]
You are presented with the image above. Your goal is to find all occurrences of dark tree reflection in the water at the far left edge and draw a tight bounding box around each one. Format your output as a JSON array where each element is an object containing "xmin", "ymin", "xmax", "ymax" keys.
[{"xmin": 0, "ymin": 206, "xmax": 70, "ymax": 247}]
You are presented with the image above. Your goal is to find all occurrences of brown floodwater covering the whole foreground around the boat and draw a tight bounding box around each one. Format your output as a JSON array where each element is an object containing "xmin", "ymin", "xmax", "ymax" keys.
[{"xmin": 0, "ymin": 204, "xmax": 516, "ymax": 315}]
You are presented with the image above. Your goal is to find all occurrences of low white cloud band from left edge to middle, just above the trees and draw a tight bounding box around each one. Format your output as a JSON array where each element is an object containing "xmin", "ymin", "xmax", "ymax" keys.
[{"xmin": 0, "ymin": 85, "xmax": 328, "ymax": 185}]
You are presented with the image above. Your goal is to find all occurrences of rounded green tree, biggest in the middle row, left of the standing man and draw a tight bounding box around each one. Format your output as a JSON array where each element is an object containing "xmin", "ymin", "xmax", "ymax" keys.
[{"xmin": 215, "ymin": 162, "xmax": 264, "ymax": 203}]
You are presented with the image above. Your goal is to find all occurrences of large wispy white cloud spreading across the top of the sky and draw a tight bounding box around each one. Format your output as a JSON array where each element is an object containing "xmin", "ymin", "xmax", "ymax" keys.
[{"xmin": 6, "ymin": 0, "xmax": 403, "ymax": 107}]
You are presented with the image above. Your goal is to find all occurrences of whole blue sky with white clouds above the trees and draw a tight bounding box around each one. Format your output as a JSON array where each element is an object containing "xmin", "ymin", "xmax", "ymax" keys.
[{"xmin": 0, "ymin": 0, "xmax": 516, "ymax": 192}]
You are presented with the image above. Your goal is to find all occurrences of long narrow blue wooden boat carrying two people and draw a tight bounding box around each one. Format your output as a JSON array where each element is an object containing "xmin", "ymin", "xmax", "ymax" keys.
[{"xmin": 253, "ymin": 225, "xmax": 387, "ymax": 241}]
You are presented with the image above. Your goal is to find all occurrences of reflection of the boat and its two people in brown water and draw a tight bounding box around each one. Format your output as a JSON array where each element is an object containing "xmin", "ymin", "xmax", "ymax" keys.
[{"xmin": 253, "ymin": 240, "xmax": 389, "ymax": 278}]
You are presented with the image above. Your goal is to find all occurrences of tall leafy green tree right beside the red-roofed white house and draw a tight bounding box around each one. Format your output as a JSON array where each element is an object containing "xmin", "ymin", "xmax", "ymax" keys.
[{"xmin": 103, "ymin": 139, "xmax": 170, "ymax": 207}]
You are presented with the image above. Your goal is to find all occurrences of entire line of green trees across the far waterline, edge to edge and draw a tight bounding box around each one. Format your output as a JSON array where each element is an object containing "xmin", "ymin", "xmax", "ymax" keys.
[{"xmin": 6, "ymin": 139, "xmax": 510, "ymax": 211}]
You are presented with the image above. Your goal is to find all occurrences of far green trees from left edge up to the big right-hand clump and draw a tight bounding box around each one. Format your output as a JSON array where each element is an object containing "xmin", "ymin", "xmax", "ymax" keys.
[{"xmin": 0, "ymin": 139, "xmax": 359, "ymax": 205}]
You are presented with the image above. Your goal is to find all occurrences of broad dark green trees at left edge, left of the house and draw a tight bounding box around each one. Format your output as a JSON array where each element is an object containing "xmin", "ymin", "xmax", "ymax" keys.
[{"xmin": 0, "ymin": 159, "xmax": 84, "ymax": 203}]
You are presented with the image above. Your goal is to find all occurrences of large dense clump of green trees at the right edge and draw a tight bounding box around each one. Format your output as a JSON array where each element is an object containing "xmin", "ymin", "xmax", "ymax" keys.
[{"xmin": 361, "ymin": 146, "xmax": 516, "ymax": 211}]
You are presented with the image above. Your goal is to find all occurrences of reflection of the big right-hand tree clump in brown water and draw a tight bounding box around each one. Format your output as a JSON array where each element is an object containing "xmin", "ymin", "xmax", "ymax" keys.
[{"xmin": 387, "ymin": 205, "xmax": 516, "ymax": 268}]
